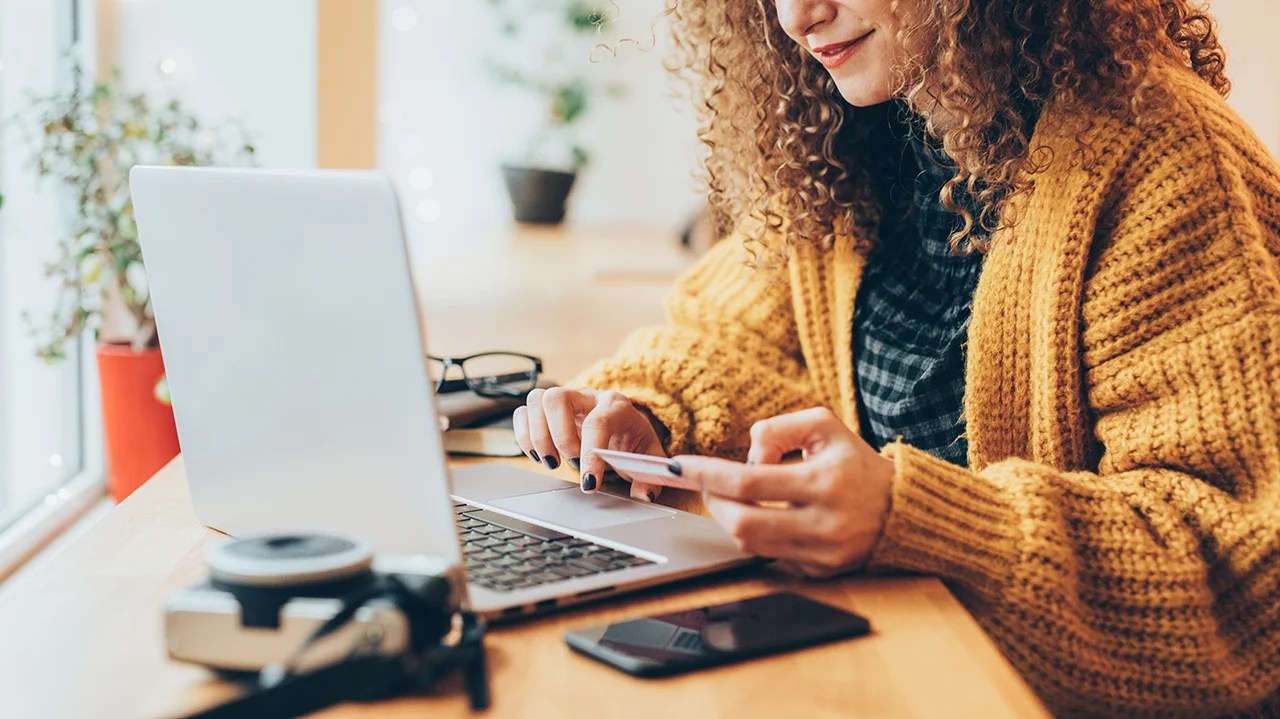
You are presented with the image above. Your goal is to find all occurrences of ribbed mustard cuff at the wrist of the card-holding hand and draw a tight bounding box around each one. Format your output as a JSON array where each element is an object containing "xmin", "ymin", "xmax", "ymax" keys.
[{"xmin": 869, "ymin": 443, "xmax": 1019, "ymax": 597}]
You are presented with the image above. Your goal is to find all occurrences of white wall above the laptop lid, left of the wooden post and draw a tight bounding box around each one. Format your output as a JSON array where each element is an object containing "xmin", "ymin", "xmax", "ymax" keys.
[{"xmin": 114, "ymin": 0, "xmax": 316, "ymax": 168}]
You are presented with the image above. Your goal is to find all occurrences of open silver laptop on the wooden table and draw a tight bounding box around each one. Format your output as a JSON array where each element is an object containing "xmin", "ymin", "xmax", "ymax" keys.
[{"xmin": 129, "ymin": 166, "xmax": 754, "ymax": 619}]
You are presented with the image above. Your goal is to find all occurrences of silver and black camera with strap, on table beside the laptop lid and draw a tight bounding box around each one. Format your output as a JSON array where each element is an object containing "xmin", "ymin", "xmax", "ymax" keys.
[{"xmin": 165, "ymin": 533, "xmax": 465, "ymax": 673}]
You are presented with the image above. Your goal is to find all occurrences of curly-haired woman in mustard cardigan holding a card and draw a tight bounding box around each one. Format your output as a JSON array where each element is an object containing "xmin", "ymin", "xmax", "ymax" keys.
[{"xmin": 517, "ymin": 0, "xmax": 1280, "ymax": 716}]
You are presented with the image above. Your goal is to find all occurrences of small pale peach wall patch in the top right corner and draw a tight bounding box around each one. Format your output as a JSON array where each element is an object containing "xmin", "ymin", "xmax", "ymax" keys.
[{"xmin": 1210, "ymin": 0, "xmax": 1280, "ymax": 155}]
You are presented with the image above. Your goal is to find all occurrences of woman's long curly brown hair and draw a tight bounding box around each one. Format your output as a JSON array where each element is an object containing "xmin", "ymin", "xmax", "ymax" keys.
[{"xmin": 667, "ymin": 0, "xmax": 1230, "ymax": 258}]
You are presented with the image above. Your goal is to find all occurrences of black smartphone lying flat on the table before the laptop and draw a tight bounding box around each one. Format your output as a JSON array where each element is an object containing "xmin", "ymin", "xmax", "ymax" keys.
[{"xmin": 564, "ymin": 592, "xmax": 870, "ymax": 677}]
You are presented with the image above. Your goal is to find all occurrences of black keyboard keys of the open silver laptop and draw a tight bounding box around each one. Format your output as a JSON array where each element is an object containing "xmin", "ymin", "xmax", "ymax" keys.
[{"xmin": 453, "ymin": 502, "xmax": 653, "ymax": 591}]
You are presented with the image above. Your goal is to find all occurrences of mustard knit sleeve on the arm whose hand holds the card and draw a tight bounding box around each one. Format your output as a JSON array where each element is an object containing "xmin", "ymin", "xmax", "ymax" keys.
[{"xmin": 873, "ymin": 101, "xmax": 1280, "ymax": 716}]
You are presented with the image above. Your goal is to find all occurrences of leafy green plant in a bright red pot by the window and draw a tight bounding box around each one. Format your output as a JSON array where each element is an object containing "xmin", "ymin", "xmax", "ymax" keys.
[{"xmin": 0, "ymin": 68, "xmax": 253, "ymax": 502}]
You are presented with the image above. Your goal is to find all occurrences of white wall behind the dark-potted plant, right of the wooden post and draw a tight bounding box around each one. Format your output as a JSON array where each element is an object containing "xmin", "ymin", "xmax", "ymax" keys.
[{"xmin": 379, "ymin": 0, "xmax": 699, "ymax": 232}]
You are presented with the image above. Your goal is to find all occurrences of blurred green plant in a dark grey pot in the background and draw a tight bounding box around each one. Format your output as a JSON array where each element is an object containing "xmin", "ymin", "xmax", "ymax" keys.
[{"xmin": 485, "ymin": 0, "xmax": 621, "ymax": 224}]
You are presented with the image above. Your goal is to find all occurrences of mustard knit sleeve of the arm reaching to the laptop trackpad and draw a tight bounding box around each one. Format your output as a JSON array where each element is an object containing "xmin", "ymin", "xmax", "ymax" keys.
[{"xmin": 572, "ymin": 218, "xmax": 819, "ymax": 458}]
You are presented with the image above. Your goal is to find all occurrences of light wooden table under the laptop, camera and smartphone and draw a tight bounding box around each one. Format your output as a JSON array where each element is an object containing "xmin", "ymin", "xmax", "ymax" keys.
[{"xmin": 0, "ymin": 222, "xmax": 1044, "ymax": 719}]
